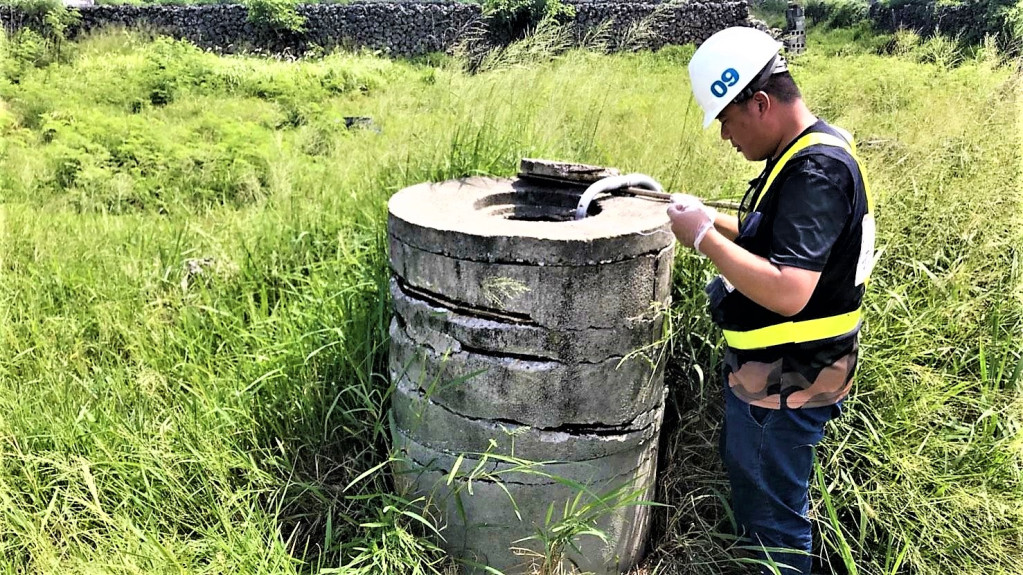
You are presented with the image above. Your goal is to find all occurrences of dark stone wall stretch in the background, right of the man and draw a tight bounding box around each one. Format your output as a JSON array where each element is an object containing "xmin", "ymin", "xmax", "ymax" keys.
[{"xmin": 871, "ymin": 0, "xmax": 998, "ymax": 43}]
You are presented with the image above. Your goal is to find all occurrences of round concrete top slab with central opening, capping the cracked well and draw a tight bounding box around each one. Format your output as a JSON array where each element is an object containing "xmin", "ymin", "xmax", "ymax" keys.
[{"xmin": 388, "ymin": 178, "xmax": 674, "ymax": 266}]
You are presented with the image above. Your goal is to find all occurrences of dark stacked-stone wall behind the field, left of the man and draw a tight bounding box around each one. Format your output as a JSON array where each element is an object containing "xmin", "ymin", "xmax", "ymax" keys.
[{"xmin": 0, "ymin": 0, "xmax": 749, "ymax": 56}]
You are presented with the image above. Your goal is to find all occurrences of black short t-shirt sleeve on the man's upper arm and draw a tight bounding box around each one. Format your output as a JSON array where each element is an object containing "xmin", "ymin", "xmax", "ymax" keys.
[{"xmin": 767, "ymin": 158, "xmax": 853, "ymax": 271}]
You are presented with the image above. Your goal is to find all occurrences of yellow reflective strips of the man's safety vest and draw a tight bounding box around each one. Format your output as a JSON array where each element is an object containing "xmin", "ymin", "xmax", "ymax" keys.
[{"xmin": 723, "ymin": 131, "xmax": 875, "ymax": 350}]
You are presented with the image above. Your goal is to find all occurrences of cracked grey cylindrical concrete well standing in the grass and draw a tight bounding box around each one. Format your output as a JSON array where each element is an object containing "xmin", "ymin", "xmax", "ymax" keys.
[{"xmin": 388, "ymin": 178, "xmax": 674, "ymax": 575}]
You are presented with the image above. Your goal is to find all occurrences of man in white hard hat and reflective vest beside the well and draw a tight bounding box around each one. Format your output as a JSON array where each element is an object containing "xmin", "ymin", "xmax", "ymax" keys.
[{"xmin": 668, "ymin": 28, "xmax": 874, "ymax": 575}]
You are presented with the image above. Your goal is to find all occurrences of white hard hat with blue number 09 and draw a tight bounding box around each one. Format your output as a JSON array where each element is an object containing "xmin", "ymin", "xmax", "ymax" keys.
[{"xmin": 690, "ymin": 27, "xmax": 788, "ymax": 128}]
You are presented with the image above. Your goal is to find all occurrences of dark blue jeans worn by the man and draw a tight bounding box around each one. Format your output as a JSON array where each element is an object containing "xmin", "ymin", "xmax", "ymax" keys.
[{"xmin": 720, "ymin": 383, "xmax": 842, "ymax": 575}]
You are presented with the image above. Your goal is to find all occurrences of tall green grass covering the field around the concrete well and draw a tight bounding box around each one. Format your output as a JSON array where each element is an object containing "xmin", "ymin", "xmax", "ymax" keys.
[{"xmin": 0, "ymin": 22, "xmax": 1023, "ymax": 574}]
